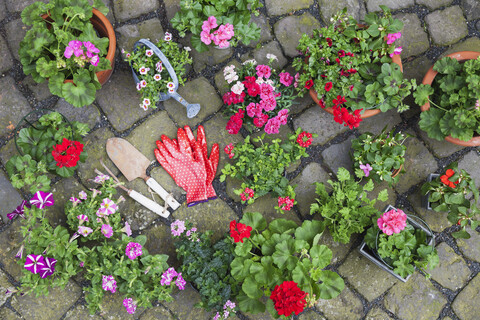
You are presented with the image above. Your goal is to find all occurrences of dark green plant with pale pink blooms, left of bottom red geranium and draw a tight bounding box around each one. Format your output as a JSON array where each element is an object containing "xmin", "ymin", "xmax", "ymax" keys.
[{"xmin": 171, "ymin": 220, "xmax": 240, "ymax": 320}]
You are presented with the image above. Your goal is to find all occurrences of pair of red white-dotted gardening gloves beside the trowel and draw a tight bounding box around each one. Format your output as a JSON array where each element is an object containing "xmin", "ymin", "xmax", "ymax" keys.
[{"xmin": 154, "ymin": 126, "xmax": 220, "ymax": 207}]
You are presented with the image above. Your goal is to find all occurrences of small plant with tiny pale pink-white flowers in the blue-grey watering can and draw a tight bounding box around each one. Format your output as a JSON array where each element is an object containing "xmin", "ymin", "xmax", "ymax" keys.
[{"xmin": 122, "ymin": 32, "xmax": 192, "ymax": 110}]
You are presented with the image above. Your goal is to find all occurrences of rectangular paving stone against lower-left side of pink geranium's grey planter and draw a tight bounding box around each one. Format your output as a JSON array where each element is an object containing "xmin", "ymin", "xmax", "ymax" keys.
[{"xmin": 338, "ymin": 250, "xmax": 399, "ymax": 301}]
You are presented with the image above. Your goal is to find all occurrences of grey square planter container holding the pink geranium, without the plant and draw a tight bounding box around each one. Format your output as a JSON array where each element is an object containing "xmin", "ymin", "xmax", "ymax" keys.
[{"xmin": 359, "ymin": 205, "xmax": 435, "ymax": 282}]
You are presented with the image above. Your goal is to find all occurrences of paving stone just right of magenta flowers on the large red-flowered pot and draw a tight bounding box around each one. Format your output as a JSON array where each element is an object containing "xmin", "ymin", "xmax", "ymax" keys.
[{"xmin": 395, "ymin": 13, "xmax": 430, "ymax": 59}]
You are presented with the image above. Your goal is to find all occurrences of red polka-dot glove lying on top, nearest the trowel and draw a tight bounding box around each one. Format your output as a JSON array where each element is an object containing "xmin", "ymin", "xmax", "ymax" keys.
[{"xmin": 154, "ymin": 128, "xmax": 207, "ymax": 206}]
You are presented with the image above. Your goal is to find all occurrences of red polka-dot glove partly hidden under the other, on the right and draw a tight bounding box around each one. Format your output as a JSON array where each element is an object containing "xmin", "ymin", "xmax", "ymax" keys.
[{"xmin": 184, "ymin": 126, "xmax": 220, "ymax": 200}]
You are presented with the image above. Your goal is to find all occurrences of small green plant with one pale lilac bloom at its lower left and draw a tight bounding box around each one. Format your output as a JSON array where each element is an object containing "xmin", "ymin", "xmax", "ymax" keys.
[{"xmin": 352, "ymin": 127, "xmax": 410, "ymax": 184}]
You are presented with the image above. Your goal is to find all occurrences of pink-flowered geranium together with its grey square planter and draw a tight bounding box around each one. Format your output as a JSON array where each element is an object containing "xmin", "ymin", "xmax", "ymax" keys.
[{"xmin": 360, "ymin": 206, "xmax": 439, "ymax": 282}]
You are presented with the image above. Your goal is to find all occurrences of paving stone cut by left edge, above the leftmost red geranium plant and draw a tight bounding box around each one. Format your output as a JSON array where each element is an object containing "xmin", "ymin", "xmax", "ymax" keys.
[{"xmin": 0, "ymin": 76, "xmax": 31, "ymax": 136}]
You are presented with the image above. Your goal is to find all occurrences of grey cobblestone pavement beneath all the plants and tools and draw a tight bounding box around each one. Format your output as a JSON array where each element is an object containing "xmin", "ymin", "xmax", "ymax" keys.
[{"xmin": 0, "ymin": 0, "xmax": 480, "ymax": 320}]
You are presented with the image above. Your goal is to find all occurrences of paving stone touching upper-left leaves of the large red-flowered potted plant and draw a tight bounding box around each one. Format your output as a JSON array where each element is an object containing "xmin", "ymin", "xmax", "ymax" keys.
[{"xmin": 273, "ymin": 12, "xmax": 320, "ymax": 57}]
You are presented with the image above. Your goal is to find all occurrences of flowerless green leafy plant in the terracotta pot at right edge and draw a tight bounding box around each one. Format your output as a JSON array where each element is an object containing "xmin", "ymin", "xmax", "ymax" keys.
[{"xmin": 413, "ymin": 57, "xmax": 480, "ymax": 141}]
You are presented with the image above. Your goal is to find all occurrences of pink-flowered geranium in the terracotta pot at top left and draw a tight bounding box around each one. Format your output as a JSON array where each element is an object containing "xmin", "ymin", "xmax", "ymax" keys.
[{"xmin": 19, "ymin": 0, "xmax": 116, "ymax": 107}]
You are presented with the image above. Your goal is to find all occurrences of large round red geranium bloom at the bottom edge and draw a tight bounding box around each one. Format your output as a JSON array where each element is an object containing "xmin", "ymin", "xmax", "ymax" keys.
[{"xmin": 270, "ymin": 281, "xmax": 307, "ymax": 317}]
